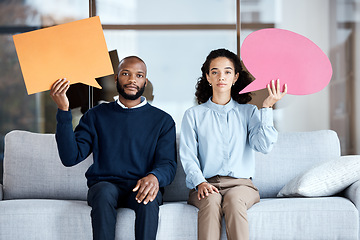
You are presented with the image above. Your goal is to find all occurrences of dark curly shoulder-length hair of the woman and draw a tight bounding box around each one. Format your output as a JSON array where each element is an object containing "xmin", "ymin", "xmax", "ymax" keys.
[{"xmin": 195, "ymin": 48, "xmax": 252, "ymax": 104}]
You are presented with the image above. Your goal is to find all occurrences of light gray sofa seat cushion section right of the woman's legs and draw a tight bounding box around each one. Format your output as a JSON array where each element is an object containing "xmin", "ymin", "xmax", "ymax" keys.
[{"xmin": 248, "ymin": 197, "xmax": 359, "ymax": 240}]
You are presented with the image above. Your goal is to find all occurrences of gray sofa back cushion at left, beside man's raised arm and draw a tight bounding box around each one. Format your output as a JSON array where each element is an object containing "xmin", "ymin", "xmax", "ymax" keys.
[{"xmin": 3, "ymin": 131, "xmax": 92, "ymax": 200}]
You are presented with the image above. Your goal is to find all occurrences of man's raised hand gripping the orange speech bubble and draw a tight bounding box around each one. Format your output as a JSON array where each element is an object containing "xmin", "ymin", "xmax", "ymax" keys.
[{"xmin": 50, "ymin": 78, "xmax": 70, "ymax": 111}]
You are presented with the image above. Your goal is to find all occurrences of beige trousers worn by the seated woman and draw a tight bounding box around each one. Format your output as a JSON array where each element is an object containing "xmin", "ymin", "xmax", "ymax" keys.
[{"xmin": 188, "ymin": 176, "xmax": 260, "ymax": 240}]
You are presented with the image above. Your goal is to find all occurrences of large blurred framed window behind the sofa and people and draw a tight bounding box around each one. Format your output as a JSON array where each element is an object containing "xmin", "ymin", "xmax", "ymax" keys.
[{"xmin": 0, "ymin": 0, "xmax": 360, "ymax": 186}]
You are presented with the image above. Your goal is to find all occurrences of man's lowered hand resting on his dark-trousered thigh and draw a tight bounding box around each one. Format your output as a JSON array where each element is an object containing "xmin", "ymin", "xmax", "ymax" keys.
[{"xmin": 133, "ymin": 174, "xmax": 159, "ymax": 204}]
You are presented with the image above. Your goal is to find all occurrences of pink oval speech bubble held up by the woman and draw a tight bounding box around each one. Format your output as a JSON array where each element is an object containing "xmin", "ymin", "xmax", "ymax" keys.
[{"xmin": 240, "ymin": 28, "xmax": 332, "ymax": 95}]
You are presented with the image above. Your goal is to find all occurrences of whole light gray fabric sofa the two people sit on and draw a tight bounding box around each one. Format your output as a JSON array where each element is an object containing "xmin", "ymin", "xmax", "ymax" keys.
[{"xmin": 0, "ymin": 131, "xmax": 360, "ymax": 240}]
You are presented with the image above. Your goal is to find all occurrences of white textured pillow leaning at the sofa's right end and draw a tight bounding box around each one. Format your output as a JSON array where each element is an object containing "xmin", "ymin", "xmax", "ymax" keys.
[{"xmin": 277, "ymin": 155, "xmax": 360, "ymax": 197}]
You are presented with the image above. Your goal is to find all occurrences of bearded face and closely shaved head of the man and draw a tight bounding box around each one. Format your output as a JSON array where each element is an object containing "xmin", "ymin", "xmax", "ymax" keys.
[{"xmin": 116, "ymin": 58, "xmax": 147, "ymax": 100}]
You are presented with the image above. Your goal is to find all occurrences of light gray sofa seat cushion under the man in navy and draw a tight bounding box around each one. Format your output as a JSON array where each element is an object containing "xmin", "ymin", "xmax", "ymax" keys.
[{"xmin": 0, "ymin": 199, "xmax": 197, "ymax": 240}]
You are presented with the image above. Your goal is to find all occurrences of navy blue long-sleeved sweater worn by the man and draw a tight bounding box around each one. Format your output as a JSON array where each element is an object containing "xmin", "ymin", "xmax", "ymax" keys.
[{"xmin": 55, "ymin": 102, "xmax": 176, "ymax": 187}]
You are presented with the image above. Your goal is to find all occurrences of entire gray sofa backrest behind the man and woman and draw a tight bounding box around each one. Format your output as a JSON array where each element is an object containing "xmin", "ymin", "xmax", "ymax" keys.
[{"xmin": 3, "ymin": 130, "xmax": 340, "ymax": 201}]
